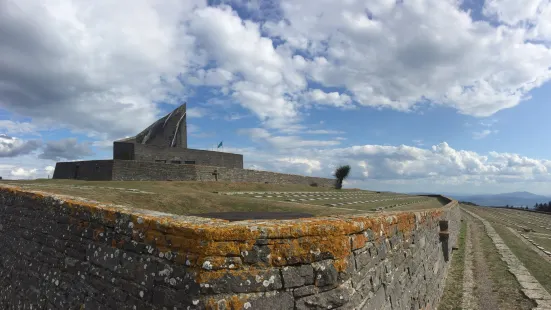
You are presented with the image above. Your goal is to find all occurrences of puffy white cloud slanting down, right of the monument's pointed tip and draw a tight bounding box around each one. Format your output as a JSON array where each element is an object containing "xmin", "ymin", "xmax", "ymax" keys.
[{"xmin": 190, "ymin": 6, "xmax": 306, "ymax": 127}]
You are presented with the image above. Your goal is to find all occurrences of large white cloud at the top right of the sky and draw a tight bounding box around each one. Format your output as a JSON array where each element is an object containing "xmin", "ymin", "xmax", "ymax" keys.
[{"xmin": 264, "ymin": 0, "xmax": 551, "ymax": 116}]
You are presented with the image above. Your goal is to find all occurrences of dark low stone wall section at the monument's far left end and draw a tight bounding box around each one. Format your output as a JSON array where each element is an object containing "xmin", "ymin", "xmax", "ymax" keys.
[{"xmin": 52, "ymin": 160, "xmax": 113, "ymax": 181}]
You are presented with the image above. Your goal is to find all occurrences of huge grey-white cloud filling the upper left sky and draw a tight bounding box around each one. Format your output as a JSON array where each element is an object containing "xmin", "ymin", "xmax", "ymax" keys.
[{"xmin": 0, "ymin": 0, "xmax": 206, "ymax": 137}]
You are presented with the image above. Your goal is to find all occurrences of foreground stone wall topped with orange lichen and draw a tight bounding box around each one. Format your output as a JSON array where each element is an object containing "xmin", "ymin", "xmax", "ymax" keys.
[{"xmin": 0, "ymin": 187, "xmax": 460, "ymax": 309}]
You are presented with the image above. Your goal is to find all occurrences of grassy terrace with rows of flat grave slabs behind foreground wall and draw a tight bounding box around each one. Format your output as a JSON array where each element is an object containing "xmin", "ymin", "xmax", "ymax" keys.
[{"xmin": 0, "ymin": 179, "xmax": 445, "ymax": 216}]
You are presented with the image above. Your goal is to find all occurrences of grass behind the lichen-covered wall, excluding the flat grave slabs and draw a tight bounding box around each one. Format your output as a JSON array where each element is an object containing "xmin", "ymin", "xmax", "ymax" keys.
[{"xmin": 0, "ymin": 179, "xmax": 448, "ymax": 216}]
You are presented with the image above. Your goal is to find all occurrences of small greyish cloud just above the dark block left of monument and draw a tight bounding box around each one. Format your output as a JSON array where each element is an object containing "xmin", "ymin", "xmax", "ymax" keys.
[{"xmin": 39, "ymin": 138, "xmax": 94, "ymax": 161}]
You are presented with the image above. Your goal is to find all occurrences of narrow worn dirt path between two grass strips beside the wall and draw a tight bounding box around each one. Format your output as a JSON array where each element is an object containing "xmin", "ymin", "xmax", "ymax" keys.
[{"xmin": 469, "ymin": 213, "xmax": 500, "ymax": 309}]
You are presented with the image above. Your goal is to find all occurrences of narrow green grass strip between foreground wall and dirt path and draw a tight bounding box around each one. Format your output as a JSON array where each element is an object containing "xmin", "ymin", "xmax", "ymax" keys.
[{"xmin": 438, "ymin": 222, "xmax": 467, "ymax": 310}]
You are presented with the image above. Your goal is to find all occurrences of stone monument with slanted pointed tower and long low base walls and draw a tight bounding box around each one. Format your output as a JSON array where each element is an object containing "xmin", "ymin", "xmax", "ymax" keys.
[{"xmin": 53, "ymin": 104, "xmax": 334, "ymax": 187}]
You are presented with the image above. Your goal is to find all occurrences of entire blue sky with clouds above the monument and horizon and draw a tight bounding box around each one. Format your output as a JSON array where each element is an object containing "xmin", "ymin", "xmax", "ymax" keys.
[{"xmin": 0, "ymin": 0, "xmax": 551, "ymax": 195}]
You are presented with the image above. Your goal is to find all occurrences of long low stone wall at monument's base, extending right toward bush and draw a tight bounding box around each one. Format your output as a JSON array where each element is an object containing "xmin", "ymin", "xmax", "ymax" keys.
[{"xmin": 113, "ymin": 160, "xmax": 335, "ymax": 187}]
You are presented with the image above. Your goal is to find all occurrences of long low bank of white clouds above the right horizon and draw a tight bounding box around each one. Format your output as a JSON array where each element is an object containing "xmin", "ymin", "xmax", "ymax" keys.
[{"xmin": 225, "ymin": 142, "xmax": 551, "ymax": 186}]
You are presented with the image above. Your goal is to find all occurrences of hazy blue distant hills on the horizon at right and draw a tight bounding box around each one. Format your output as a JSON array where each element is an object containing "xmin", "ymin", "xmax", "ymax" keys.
[{"xmin": 415, "ymin": 192, "xmax": 551, "ymax": 208}]
